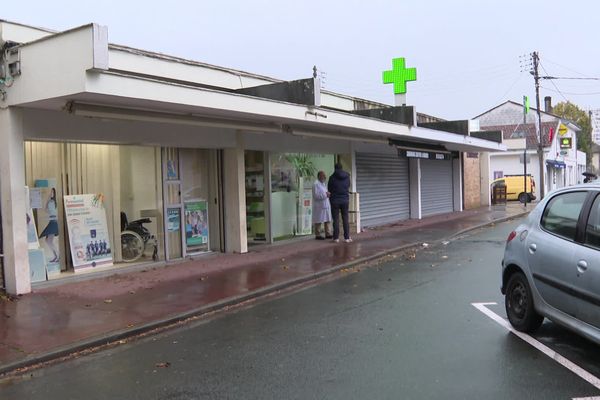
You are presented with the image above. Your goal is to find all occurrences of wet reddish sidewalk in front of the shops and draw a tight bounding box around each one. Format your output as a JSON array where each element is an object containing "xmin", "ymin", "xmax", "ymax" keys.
[{"xmin": 0, "ymin": 203, "xmax": 533, "ymax": 374}]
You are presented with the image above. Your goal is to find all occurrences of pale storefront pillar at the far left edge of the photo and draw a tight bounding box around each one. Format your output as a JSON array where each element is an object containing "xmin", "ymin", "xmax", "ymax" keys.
[{"xmin": 0, "ymin": 109, "xmax": 31, "ymax": 295}]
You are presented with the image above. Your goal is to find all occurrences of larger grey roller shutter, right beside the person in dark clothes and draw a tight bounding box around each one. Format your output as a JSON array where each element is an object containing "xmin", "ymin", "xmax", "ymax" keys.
[{"xmin": 356, "ymin": 153, "xmax": 410, "ymax": 227}]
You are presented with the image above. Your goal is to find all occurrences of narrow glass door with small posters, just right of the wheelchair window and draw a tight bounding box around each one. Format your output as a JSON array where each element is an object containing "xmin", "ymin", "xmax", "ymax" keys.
[{"xmin": 162, "ymin": 148, "xmax": 184, "ymax": 260}]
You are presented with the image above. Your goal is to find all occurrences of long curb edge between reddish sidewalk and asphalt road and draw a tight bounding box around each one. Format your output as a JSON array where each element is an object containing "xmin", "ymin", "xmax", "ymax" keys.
[{"xmin": 0, "ymin": 210, "xmax": 531, "ymax": 378}]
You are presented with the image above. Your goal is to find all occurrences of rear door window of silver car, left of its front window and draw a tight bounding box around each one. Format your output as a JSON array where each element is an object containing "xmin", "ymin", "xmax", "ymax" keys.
[{"xmin": 541, "ymin": 192, "xmax": 587, "ymax": 240}]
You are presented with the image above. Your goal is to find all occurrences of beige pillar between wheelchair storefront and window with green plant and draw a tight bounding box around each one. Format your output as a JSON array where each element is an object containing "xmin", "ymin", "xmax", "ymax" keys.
[{"xmin": 223, "ymin": 133, "xmax": 248, "ymax": 253}]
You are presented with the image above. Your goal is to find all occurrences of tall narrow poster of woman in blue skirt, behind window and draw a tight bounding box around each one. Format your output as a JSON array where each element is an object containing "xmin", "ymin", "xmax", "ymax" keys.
[{"xmin": 32, "ymin": 178, "xmax": 60, "ymax": 276}]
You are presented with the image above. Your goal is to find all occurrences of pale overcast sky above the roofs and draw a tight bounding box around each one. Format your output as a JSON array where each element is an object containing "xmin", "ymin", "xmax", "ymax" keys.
[{"xmin": 0, "ymin": 0, "xmax": 600, "ymax": 119}]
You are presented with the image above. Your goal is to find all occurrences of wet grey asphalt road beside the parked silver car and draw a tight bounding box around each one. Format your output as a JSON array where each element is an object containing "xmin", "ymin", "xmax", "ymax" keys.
[{"xmin": 0, "ymin": 222, "xmax": 600, "ymax": 400}]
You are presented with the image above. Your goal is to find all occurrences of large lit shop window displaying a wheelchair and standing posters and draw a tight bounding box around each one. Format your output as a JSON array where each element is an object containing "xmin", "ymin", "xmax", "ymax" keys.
[{"xmin": 25, "ymin": 142, "xmax": 164, "ymax": 279}]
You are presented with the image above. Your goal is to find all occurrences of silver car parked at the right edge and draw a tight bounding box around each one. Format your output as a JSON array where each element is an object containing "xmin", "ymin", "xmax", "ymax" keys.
[{"xmin": 501, "ymin": 183, "xmax": 600, "ymax": 344}]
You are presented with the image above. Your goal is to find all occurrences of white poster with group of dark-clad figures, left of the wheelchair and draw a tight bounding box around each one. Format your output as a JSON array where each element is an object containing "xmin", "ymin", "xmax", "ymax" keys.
[{"xmin": 64, "ymin": 194, "xmax": 113, "ymax": 271}]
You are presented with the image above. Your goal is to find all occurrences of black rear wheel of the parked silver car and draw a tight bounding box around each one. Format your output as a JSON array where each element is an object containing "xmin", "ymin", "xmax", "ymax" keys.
[{"xmin": 504, "ymin": 272, "xmax": 544, "ymax": 332}]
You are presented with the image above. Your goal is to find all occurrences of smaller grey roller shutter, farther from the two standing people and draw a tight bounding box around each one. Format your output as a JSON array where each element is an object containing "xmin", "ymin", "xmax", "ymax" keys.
[{"xmin": 421, "ymin": 160, "xmax": 454, "ymax": 217}]
